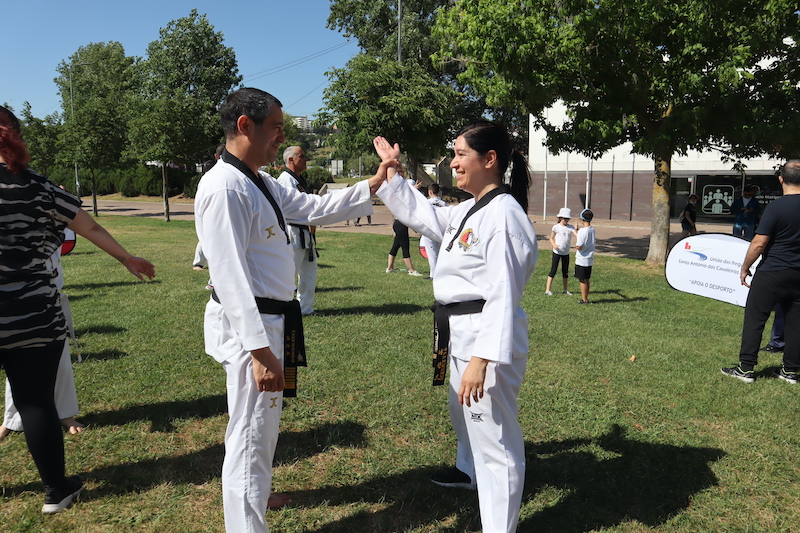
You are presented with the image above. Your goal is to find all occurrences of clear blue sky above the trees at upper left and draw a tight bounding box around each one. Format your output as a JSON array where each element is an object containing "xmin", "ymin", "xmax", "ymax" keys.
[{"xmin": 0, "ymin": 0, "xmax": 359, "ymax": 118}]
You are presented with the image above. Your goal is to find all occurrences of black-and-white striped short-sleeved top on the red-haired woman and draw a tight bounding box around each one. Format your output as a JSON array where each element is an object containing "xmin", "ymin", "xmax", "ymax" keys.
[{"xmin": 0, "ymin": 163, "xmax": 80, "ymax": 350}]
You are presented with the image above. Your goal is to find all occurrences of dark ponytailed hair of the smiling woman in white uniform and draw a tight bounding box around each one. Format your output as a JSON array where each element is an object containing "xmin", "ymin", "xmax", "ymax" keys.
[{"xmin": 456, "ymin": 120, "xmax": 531, "ymax": 213}]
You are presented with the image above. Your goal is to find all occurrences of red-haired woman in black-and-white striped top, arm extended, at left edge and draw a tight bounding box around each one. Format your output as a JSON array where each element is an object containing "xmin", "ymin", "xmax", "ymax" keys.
[{"xmin": 0, "ymin": 107, "xmax": 155, "ymax": 513}]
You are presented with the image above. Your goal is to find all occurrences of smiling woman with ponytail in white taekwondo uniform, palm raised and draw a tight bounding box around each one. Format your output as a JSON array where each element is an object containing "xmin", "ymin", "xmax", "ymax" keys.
[{"xmin": 375, "ymin": 121, "xmax": 537, "ymax": 533}]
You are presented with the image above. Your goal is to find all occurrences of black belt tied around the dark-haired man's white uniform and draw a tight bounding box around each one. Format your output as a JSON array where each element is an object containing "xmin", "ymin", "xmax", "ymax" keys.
[{"xmin": 211, "ymin": 290, "xmax": 308, "ymax": 398}]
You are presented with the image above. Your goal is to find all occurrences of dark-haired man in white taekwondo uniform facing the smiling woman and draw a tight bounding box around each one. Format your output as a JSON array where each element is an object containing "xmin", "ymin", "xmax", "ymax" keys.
[{"xmin": 195, "ymin": 88, "xmax": 379, "ymax": 533}]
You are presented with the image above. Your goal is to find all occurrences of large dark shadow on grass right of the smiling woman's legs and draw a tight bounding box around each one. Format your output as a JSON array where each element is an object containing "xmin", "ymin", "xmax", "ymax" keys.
[{"xmin": 519, "ymin": 424, "xmax": 726, "ymax": 533}]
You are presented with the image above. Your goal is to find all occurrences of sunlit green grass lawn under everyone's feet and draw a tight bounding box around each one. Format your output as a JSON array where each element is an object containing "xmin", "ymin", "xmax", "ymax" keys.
[{"xmin": 0, "ymin": 217, "xmax": 800, "ymax": 533}]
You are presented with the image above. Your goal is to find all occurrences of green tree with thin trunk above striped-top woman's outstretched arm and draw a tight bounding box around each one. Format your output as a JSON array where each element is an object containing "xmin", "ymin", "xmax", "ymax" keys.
[{"xmin": 55, "ymin": 42, "xmax": 134, "ymax": 216}]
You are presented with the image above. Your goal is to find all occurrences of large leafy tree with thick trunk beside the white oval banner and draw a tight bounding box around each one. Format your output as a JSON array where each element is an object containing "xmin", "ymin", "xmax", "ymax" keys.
[{"xmin": 435, "ymin": 0, "xmax": 800, "ymax": 264}]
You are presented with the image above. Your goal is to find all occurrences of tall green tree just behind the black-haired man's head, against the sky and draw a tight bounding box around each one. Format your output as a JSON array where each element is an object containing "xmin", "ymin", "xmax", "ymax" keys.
[{"xmin": 129, "ymin": 9, "xmax": 242, "ymax": 221}]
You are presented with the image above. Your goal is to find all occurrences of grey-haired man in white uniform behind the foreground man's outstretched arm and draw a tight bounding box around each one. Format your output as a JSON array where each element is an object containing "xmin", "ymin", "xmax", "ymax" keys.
[{"xmin": 278, "ymin": 146, "xmax": 317, "ymax": 315}]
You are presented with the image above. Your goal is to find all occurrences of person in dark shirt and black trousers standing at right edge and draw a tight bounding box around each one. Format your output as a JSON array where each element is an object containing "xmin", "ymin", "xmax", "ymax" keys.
[{"xmin": 722, "ymin": 159, "xmax": 800, "ymax": 384}]
